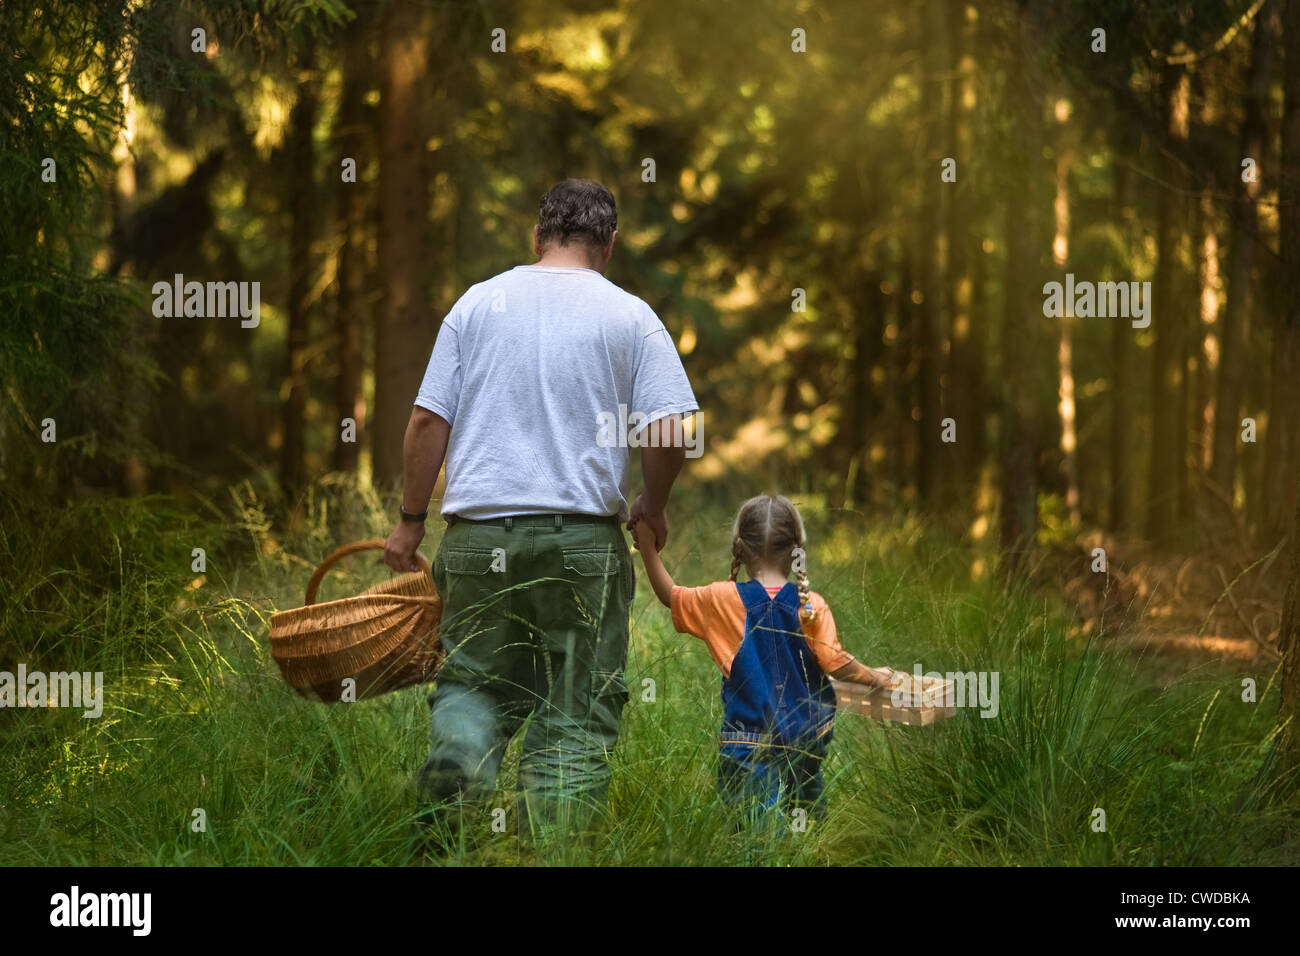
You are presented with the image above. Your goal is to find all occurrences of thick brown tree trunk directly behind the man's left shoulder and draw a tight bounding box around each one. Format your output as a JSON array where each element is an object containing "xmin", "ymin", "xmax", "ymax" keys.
[{"xmin": 369, "ymin": 4, "xmax": 437, "ymax": 488}]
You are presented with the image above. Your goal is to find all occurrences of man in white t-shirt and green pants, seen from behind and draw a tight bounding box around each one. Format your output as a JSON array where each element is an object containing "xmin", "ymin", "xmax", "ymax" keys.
[{"xmin": 385, "ymin": 179, "xmax": 698, "ymax": 832}]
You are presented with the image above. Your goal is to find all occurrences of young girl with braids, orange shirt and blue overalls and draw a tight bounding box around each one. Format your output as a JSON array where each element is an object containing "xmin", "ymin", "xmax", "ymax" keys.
[{"xmin": 632, "ymin": 494, "xmax": 893, "ymax": 810}]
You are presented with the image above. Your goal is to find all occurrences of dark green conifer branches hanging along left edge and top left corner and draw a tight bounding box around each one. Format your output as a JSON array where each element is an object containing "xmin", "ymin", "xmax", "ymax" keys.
[{"xmin": 0, "ymin": 0, "xmax": 361, "ymax": 499}]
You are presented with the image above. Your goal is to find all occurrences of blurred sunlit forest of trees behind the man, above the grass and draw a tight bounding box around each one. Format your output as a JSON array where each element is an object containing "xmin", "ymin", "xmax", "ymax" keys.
[{"xmin": 0, "ymin": 0, "xmax": 1300, "ymax": 868}]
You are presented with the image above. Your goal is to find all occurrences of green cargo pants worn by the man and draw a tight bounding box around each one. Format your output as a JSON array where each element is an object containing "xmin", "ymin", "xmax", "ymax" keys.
[{"xmin": 419, "ymin": 515, "xmax": 636, "ymax": 834}]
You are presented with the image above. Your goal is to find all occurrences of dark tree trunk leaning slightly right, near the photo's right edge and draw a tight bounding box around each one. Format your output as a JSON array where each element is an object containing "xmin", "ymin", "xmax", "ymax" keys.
[{"xmin": 1209, "ymin": 3, "xmax": 1277, "ymax": 520}]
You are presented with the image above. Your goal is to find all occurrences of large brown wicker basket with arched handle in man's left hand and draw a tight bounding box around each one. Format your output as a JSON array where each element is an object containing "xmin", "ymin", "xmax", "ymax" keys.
[{"xmin": 270, "ymin": 538, "xmax": 443, "ymax": 704}]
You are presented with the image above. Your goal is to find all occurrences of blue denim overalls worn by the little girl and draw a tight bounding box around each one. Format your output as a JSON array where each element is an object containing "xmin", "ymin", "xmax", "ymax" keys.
[{"xmin": 718, "ymin": 581, "xmax": 836, "ymax": 809}]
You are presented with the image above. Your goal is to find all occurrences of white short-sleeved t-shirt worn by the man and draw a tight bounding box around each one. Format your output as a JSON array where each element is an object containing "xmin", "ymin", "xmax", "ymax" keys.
[{"xmin": 415, "ymin": 265, "xmax": 699, "ymax": 520}]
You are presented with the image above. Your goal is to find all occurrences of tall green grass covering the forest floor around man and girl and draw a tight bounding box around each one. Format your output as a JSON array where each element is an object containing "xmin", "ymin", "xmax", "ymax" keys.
[{"xmin": 0, "ymin": 484, "xmax": 1300, "ymax": 865}]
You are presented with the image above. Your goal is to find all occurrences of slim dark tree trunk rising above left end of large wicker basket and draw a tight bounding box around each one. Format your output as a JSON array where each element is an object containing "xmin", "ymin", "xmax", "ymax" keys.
[{"xmin": 280, "ymin": 47, "xmax": 320, "ymax": 498}]
